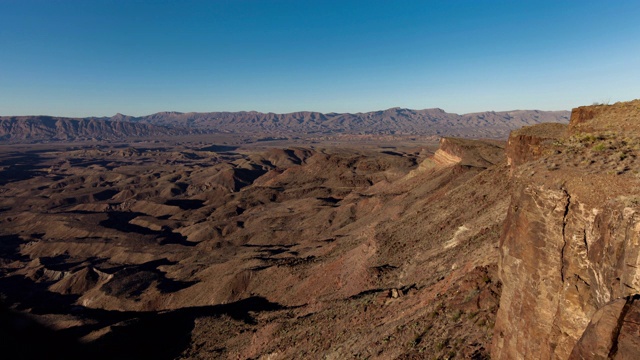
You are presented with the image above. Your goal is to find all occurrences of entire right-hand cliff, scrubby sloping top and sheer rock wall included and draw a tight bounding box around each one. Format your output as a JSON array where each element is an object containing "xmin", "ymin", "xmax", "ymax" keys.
[{"xmin": 492, "ymin": 101, "xmax": 640, "ymax": 359}]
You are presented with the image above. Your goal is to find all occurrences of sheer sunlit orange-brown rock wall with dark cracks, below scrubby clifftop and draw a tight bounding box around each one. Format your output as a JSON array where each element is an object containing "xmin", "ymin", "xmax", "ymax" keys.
[{"xmin": 494, "ymin": 184, "xmax": 640, "ymax": 359}]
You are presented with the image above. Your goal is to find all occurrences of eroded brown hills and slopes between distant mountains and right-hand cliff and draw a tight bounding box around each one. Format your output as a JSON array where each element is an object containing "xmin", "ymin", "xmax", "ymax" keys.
[{"xmin": 0, "ymin": 139, "xmax": 510, "ymax": 359}]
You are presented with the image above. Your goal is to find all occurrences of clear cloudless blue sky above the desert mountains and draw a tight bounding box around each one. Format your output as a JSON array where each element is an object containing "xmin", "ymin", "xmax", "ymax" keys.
[{"xmin": 0, "ymin": 0, "xmax": 640, "ymax": 116}]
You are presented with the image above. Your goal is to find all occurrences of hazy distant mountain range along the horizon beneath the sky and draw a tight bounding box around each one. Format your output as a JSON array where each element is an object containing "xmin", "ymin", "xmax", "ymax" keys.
[{"xmin": 0, "ymin": 108, "xmax": 570, "ymax": 141}]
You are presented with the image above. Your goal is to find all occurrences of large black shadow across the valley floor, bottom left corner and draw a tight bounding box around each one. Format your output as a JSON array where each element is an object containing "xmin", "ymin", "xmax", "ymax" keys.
[{"xmin": 0, "ymin": 290, "xmax": 287, "ymax": 359}]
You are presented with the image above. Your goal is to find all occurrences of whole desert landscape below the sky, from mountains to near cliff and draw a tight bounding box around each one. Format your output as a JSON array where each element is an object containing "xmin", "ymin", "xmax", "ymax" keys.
[{"xmin": 0, "ymin": 100, "xmax": 640, "ymax": 360}]
